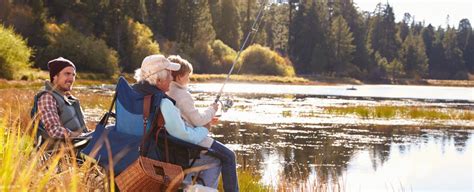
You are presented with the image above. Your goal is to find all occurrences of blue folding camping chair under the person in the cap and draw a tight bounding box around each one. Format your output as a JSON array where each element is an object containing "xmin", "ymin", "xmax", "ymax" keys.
[{"xmin": 82, "ymin": 77, "xmax": 216, "ymax": 187}]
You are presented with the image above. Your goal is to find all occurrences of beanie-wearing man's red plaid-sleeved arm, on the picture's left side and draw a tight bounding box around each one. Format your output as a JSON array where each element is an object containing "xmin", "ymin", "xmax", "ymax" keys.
[{"xmin": 38, "ymin": 93, "xmax": 71, "ymax": 138}]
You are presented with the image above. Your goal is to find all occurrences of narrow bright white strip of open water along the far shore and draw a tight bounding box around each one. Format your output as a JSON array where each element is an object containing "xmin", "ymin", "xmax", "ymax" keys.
[{"xmin": 190, "ymin": 83, "xmax": 474, "ymax": 102}]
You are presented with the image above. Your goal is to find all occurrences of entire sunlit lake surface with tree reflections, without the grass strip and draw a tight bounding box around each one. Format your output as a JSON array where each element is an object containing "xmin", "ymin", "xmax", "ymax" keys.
[{"xmin": 81, "ymin": 84, "xmax": 474, "ymax": 191}]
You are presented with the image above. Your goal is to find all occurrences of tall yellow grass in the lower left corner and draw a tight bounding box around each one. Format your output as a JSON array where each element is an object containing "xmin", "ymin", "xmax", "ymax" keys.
[{"xmin": 0, "ymin": 109, "xmax": 107, "ymax": 192}]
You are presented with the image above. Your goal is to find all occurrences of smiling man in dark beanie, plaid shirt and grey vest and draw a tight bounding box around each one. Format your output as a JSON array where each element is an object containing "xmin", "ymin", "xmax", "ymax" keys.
[{"xmin": 33, "ymin": 57, "xmax": 87, "ymax": 138}]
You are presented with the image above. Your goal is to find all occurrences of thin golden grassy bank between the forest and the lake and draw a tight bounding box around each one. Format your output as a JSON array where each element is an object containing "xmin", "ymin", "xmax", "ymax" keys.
[{"xmin": 0, "ymin": 73, "xmax": 474, "ymax": 89}]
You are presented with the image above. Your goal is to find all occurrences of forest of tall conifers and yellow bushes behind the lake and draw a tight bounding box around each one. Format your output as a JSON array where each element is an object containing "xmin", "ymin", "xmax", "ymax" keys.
[{"xmin": 0, "ymin": 0, "xmax": 474, "ymax": 81}]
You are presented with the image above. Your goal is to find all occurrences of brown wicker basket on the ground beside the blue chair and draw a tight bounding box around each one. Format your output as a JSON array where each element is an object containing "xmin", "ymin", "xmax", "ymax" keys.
[{"xmin": 115, "ymin": 156, "xmax": 184, "ymax": 191}]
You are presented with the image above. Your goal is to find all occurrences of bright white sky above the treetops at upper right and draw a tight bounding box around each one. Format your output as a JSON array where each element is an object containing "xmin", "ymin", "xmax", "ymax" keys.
[{"xmin": 353, "ymin": 0, "xmax": 474, "ymax": 28}]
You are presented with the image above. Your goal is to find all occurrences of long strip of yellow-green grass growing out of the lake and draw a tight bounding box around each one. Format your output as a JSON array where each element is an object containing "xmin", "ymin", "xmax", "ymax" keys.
[{"xmin": 324, "ymin": 106, "xmax": 474, "ymax": 121}]
